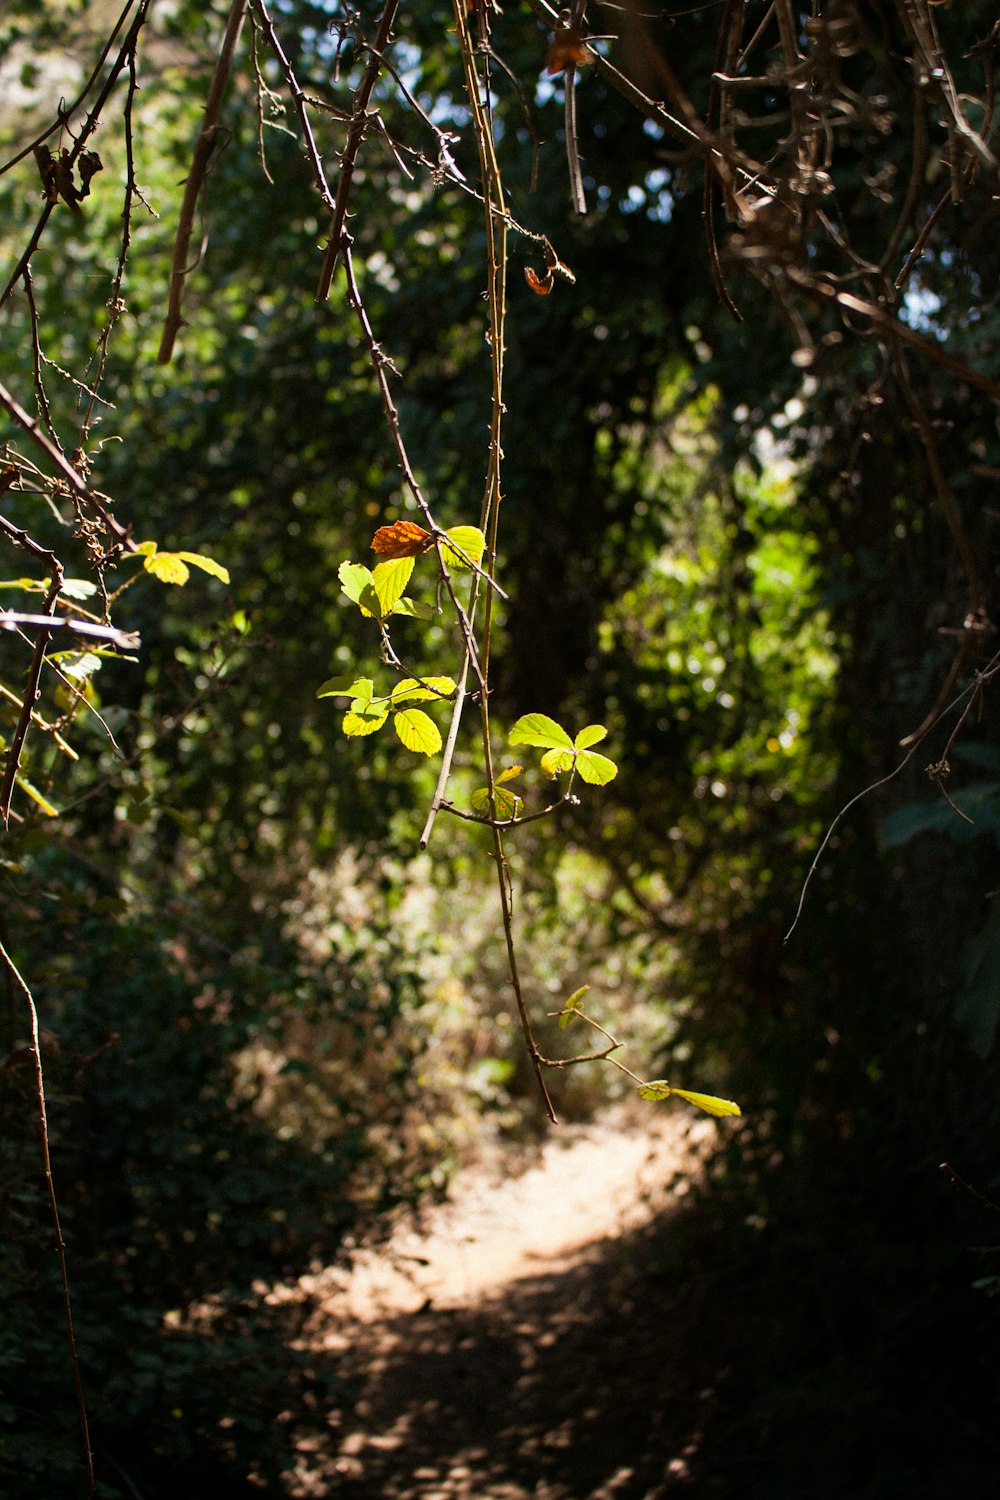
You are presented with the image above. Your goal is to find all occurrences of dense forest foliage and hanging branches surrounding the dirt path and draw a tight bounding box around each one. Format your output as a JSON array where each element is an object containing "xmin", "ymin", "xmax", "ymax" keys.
[{"xmin": 0, "ymin": 0, "xmax": 1000, "ymax": 1497}]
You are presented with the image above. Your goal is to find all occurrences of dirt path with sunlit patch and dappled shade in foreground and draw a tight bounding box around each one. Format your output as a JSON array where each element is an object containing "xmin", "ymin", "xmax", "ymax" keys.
[{"xmin": 275, "ymin": 1112, "xmax": 728, "ymax": 1500}]
